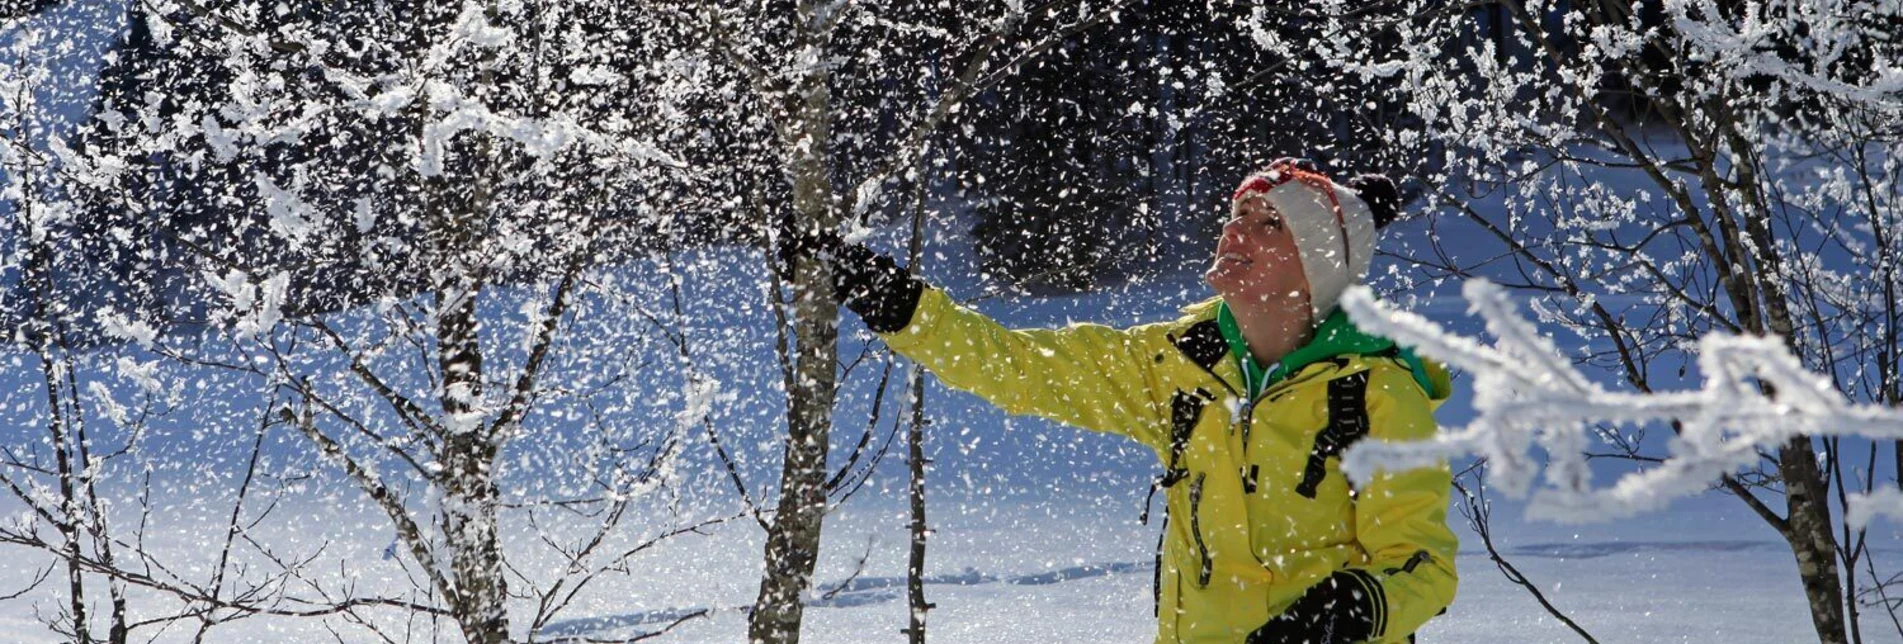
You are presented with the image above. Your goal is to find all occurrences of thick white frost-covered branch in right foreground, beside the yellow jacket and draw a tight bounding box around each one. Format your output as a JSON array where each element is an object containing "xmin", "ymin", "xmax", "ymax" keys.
[{"xmin": 1342, "ymin": 280, "xmax": 1903, "ymax": 522}]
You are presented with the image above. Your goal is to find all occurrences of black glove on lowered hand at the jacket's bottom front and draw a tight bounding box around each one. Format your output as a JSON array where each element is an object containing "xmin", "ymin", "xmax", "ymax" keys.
[{"xmin": 1248, "ymin": 570, "xmax": 1380, "ymax": 644}]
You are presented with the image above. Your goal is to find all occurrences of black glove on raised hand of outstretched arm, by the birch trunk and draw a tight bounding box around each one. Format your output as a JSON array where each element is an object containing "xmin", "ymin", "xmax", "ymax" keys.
[{"xmin": 778, "ymin": 225, "xmax": 925, "ymax": 333}]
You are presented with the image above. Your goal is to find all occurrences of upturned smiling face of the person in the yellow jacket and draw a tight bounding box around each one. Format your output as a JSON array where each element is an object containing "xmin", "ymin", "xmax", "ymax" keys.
[{"xmin": 1203, "ymin": 192, "xmax": 1307, "ymax": 314}]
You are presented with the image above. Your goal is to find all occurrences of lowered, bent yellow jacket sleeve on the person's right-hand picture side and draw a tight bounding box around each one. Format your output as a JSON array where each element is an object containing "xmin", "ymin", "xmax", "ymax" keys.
[{"xmin": 1355, "ymin": 366, "xmax": 1458, "ymax": 642}]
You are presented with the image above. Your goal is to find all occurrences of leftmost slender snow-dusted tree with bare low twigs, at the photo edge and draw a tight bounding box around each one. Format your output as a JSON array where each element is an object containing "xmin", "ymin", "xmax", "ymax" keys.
[{"xmin": 0, "ymin": 4, "xmax": 405, "ymax": 644}]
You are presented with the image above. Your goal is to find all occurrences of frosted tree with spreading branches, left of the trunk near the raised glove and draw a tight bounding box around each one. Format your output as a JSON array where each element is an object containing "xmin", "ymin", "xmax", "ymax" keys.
[{"xmin": 10, "ymin": 2, "xmax": 727, "ymax": 642}]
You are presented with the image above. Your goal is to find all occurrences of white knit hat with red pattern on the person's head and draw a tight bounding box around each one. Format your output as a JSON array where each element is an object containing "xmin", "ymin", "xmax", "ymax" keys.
[{"xmin": 1231, "ymin": 160, "xmax": 1376, "ymax": 324}]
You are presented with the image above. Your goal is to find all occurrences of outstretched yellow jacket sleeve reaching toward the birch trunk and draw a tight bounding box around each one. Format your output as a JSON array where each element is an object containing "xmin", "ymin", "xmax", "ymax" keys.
[{"xmin": 881, "ymin": 288, "xmax": 1174, "ymax": 450}]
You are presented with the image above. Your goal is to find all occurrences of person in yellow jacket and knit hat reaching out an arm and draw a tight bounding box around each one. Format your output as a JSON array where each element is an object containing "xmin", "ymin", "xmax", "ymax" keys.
[{"xmin": 794, "ymin": 160, "xmax": 1458, "ymax": 644}]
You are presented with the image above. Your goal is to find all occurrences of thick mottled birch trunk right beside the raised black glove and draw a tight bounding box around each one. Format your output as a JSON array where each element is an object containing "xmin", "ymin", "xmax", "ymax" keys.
[{"xmin": 748, "ymin": 55, "xmax": 839, "ymax": 644}]
